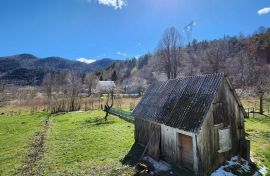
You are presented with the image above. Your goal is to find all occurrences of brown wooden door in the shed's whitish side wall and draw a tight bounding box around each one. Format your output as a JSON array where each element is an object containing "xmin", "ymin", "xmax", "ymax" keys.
[{"xmin": 178, "ymin": 134, "xmax": 194, "ymax": 170}]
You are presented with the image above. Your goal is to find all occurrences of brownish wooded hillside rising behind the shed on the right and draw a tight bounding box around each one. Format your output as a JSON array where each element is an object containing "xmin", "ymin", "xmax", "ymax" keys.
[{"xmin": 98, "ymin": 28, "xmax": 270, "ymax": 91}]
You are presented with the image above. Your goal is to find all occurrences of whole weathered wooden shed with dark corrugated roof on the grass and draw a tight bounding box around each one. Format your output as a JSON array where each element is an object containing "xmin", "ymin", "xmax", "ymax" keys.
[{"xmin": 133, "ymin": 73, "xmax": 249, "ymax": 175}]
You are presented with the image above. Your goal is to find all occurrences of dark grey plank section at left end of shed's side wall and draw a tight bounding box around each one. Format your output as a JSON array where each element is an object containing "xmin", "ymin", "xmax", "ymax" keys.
[{"xmin": 135, "ymin": 118, "xmax": 161, "ymax": 159}]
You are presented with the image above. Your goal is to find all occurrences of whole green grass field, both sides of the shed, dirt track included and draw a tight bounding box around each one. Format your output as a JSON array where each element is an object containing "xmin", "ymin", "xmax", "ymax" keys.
[{"xmin": 0, "ymin": 97, "xmax": 270, "ymax": 176}]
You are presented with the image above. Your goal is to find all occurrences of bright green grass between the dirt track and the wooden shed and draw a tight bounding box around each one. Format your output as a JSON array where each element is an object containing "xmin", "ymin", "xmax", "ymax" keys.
[{"xmin": 39, "ymin": 111, "xmax": 134, "ymax": 175}]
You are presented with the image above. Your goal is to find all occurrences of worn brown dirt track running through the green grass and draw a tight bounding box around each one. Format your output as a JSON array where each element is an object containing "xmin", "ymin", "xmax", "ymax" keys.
[{"xmin": 19, "ymin": 115, "xmax": 52, "ymax": 176}]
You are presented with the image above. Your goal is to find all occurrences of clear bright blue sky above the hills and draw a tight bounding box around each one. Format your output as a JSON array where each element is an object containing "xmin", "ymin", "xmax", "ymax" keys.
[{"xmin": 0, "ymin": 0, "xmax": 270, "ymax": 59}]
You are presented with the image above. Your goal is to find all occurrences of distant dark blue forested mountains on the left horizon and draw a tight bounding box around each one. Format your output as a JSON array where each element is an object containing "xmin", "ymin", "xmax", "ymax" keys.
[{"xmin": 0, "ymin": 54, "xmax": 117, "ymax": 85}]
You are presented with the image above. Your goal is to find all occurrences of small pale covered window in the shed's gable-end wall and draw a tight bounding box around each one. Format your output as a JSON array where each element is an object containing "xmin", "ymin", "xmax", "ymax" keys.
[{"xmin": 218, "ymin": 127, "xmax": 232, "ymax": 153}]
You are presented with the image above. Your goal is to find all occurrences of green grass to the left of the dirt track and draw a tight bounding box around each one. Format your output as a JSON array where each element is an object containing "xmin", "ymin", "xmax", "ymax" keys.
[{"xmin": 0, "ymin": 113, "xmax": 45, "ymax": 175}]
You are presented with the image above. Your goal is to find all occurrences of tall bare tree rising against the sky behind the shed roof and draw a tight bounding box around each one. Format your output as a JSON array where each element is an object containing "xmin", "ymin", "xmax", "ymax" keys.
[{"xmin": 157, "ymin": 27, "xmax": 181, "ymax": 79}]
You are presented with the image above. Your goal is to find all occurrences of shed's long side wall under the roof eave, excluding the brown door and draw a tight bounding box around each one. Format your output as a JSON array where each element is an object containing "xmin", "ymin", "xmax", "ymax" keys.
[{"xmin": 135, "ymin": 118, "xmax": 197, "ymax": 170}]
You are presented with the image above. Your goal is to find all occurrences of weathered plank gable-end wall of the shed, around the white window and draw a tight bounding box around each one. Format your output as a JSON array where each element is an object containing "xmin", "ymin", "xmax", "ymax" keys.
[{"xmin": 198, "ymin": 79, "xmax": 245, "ymax": 175}]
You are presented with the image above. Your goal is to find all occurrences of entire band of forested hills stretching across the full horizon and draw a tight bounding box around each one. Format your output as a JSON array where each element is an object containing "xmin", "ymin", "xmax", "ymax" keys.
[{"xmin": 0, "ymin": 28, "xmax": 270, "ymax": 90}]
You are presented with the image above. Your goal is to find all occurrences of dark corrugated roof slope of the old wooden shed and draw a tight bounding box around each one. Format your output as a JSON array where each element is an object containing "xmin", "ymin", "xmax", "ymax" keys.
[{"xmin": 133, "ymin": 73, "xmax": 224, "ymax": 132}]
